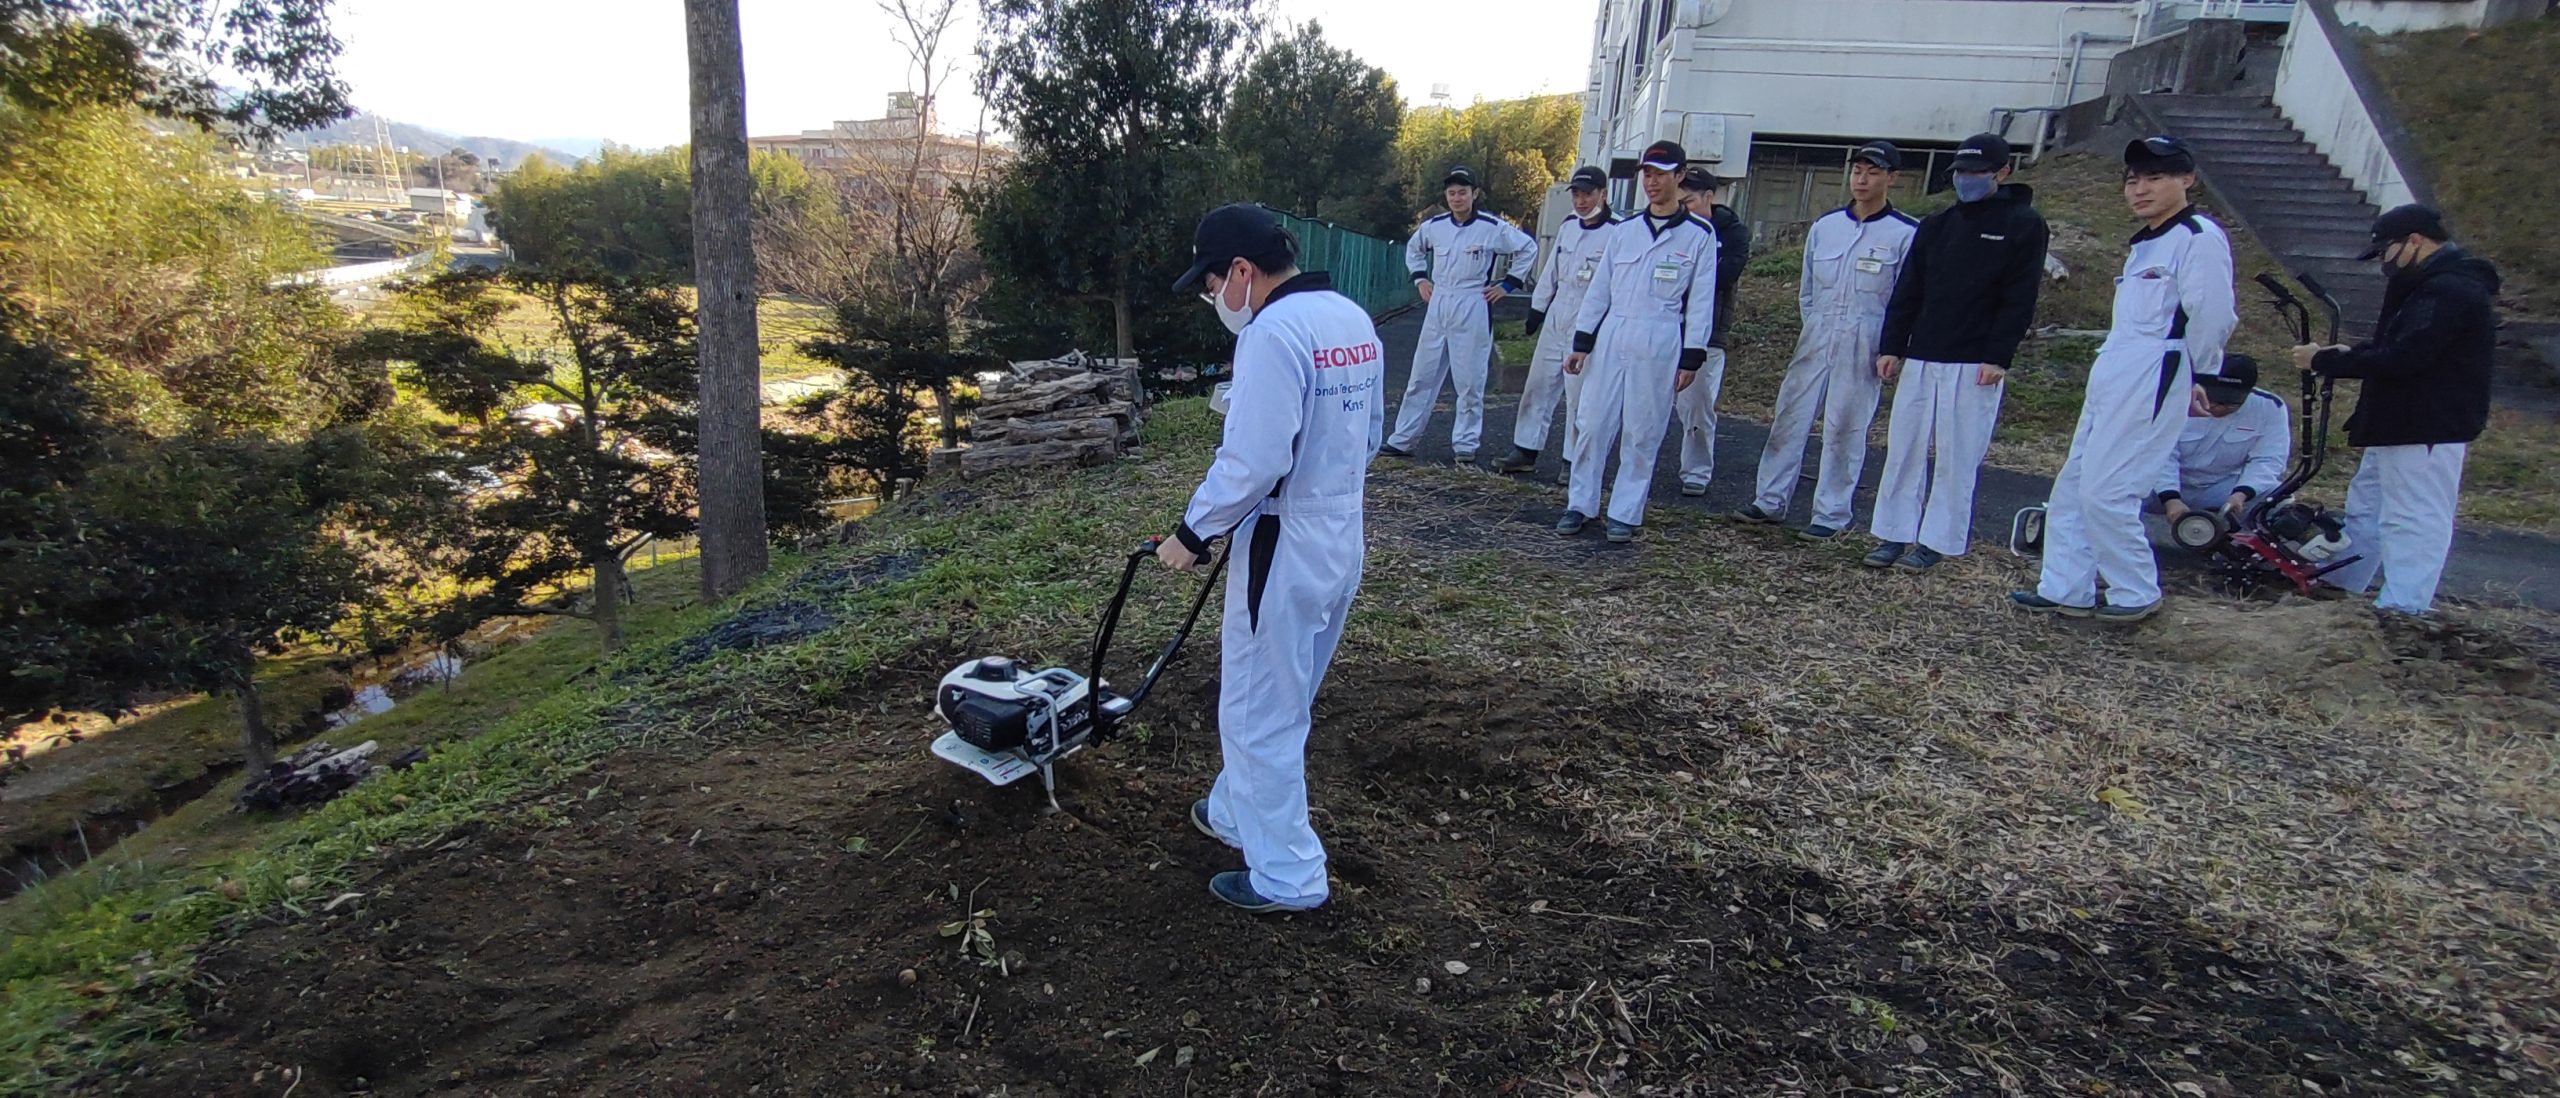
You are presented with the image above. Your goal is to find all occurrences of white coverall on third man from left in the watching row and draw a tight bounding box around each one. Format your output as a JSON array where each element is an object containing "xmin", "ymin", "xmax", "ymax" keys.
[{"xmin": 1564, "ymin": 212, "xmax": 1715, "ymax": 527}]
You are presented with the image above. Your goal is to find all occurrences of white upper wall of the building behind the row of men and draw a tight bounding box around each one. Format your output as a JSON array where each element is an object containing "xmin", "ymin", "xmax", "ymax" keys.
[{"xmin": 1582, "ymin": 0, "xmax": 2145, "ymax": 174}]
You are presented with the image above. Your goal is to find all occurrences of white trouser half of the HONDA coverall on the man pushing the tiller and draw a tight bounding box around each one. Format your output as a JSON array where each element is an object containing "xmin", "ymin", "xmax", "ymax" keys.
[{"xmin": 1208, "ymin": 509, "xmax": 1364, "ymax": 909}]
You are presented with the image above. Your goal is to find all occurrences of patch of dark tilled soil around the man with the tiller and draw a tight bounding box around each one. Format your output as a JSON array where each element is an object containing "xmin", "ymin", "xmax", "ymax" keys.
[{"xmin": 115, "ymin": 645, "xmax": 2501, "ymax": 1098}]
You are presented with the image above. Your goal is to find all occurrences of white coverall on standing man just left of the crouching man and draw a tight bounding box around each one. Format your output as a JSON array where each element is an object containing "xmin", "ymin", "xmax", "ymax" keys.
[{"xmin": 2035, "ymin": 207, "xmax": 2240, "ymax": 607}]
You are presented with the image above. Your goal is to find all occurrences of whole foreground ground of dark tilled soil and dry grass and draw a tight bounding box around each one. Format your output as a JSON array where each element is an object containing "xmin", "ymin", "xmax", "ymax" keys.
[{"xmin": 92, "ymin": 463, "xmax": 2560, "ymax": 1098}]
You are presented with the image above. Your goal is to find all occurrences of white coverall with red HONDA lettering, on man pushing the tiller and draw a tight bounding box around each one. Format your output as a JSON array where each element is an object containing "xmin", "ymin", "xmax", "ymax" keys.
[{"xmin": 1178, "ymin": 274, "xmax": 1385, "ymax": 909}]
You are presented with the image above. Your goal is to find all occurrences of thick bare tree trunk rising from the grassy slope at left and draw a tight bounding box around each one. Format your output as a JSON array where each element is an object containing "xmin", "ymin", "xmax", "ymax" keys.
[{"xmin": 686, "ymin": 0, "xmax": 765, "ymax": 598}]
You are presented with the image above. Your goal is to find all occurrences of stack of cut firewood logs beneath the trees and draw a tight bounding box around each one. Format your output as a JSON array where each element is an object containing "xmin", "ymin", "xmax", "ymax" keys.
[{"xmin": 932, "ymin": 351, "xmax": 1147, "ymax": 476}]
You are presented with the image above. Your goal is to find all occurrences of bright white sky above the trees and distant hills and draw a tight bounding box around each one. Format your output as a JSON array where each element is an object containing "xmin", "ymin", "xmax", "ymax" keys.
[{"xmin": 333, "ymin": 0, "xmax": 1595, "ymax": 148}]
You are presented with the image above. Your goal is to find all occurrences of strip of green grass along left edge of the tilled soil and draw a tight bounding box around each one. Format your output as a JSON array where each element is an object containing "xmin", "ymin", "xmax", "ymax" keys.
[{"xmin": 0, "ymin": 402, "xmax": 1219, "ymax": 1098}]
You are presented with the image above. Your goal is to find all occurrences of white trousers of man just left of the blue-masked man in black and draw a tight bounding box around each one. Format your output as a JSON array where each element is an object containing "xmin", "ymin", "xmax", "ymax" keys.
[{"xmin": 1754, "ymin": 348, "xmax": 1884, "ymax": 530}]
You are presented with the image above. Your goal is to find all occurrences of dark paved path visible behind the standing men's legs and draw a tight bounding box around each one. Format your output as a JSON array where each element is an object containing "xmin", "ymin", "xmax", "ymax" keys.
[{"xmin": 1377, "ymin": 299, "xmax": 2560, "ymax": 612}]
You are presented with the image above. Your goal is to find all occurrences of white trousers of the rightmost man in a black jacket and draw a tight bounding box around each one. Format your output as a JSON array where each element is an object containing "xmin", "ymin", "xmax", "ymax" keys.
[{"xmin": 2324, "ymin": 443, "xmax": 2470, "ymax": 614}]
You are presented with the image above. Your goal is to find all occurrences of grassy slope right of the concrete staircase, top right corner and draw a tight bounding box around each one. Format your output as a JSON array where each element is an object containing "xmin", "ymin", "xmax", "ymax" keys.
[{"xmin": 2368, "ymin": 18, "xmax": 2560, "ymax": 317}]
